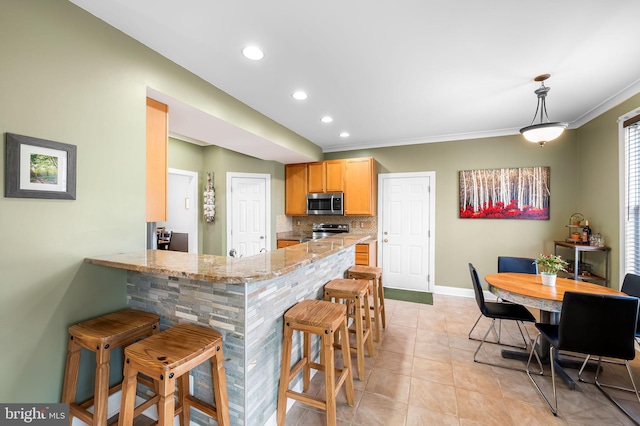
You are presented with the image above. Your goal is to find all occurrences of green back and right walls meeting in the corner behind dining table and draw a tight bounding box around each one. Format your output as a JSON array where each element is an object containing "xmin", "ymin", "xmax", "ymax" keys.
[{"xmin": 325, "ymin": 94, "xmax": 640, "ymax": 288}]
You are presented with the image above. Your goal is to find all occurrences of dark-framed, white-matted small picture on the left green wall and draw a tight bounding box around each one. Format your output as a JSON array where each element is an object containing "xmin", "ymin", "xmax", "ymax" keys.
[{"xmin": 4, "ymin": 133, "xmax": 77, "ymax": 200}]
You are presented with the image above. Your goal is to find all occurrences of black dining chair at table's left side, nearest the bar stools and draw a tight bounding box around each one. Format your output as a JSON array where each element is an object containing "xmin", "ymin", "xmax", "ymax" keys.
[{"xmin": 469, "ymin": 263, "xmax": 542, "ymax": 371}]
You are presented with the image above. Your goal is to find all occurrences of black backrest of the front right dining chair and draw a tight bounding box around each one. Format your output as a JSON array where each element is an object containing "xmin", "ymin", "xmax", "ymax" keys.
[{"xmin": 558, "ymin": 292, "xmax": 638, "ymax": 360}]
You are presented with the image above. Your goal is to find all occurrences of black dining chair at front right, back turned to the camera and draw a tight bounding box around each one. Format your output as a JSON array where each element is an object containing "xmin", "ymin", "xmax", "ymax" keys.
[{"xmin": 527, "ymin": 292, "xmax": 640, "ymax": 423}]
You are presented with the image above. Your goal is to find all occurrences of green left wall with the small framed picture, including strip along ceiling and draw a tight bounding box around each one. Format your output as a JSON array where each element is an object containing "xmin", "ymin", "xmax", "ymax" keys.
[{"xmin": 0, "ymin": 0, "xmax": 312, "ymax": 403}]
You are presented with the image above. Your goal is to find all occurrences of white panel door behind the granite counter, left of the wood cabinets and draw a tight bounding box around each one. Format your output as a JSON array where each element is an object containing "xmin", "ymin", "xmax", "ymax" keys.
[{"xmin": 227, "ymin": 174, "xmax": 269, "ymax": 257}]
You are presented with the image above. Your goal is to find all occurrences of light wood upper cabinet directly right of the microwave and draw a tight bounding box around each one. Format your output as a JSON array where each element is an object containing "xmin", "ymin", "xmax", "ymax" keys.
[{"xmin": 344, "ymin": 157, "xmax": 377, "ymax": 216}]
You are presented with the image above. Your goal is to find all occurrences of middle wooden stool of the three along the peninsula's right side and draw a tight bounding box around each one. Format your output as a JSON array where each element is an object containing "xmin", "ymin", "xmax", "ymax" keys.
[{"xmin": 324, "ymin": 278, "xmax": 374, "ymax": 380}]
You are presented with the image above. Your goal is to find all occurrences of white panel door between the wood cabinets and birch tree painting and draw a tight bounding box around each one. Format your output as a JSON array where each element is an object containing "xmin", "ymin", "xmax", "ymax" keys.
[{"xmin": 378, "ymin": 172, "xmax": 435, "ymax": 291}]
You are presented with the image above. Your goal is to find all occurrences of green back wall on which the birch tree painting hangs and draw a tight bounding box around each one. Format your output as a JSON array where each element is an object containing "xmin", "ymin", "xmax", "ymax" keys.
[{"xmin": 325, "ymin": 131, "xmax": 578, "ymax": 288}]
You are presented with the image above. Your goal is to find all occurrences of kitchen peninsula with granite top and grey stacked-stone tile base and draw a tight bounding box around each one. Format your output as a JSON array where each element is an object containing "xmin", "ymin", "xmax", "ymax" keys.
[{"xmin": 86, "ymin": 234, "xmax": 370, "ymax": 425}]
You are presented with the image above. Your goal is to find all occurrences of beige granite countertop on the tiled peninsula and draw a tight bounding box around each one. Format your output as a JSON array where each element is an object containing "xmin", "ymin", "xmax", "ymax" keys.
[{"xmin": 85, "ymin": 233, "xmax": 371, "ymax": 284}]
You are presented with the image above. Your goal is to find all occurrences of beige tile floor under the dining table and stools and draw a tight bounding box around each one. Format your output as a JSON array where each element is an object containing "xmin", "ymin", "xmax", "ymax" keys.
[{"xmin": 286, "ymin": 295, "xmax": 640, "ymax": 426}]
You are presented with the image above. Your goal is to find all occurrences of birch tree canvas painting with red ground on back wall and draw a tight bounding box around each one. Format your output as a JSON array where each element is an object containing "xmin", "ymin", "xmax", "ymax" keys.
[{"xmin": 460, "ymin": 167, "xmax": 551, "ymax": 220}]
